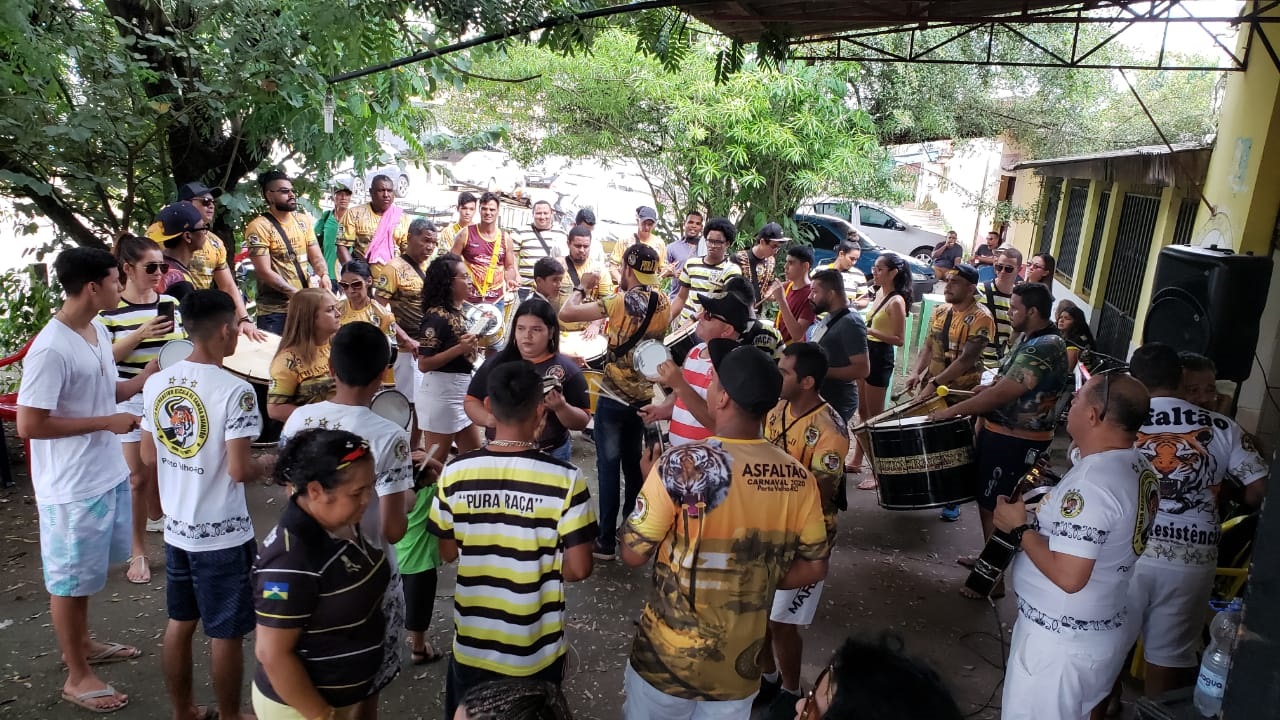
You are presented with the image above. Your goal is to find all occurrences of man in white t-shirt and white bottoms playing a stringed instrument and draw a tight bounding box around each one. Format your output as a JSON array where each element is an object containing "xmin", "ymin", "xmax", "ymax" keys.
[{"xmin": 993, "ymin": 373, "xmax": 1160, "ymax": 720}]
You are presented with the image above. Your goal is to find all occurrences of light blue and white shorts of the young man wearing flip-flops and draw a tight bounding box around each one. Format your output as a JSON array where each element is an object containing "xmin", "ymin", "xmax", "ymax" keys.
[{"xmin": 38, "ymin": 477, "xmax": 133, "ymax": 597}]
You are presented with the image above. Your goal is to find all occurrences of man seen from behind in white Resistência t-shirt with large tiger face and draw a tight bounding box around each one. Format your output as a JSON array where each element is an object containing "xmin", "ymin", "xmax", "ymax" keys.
[{"xmin": 1129, "ymin": 342, "xmax": 1267, "ymax": 697}]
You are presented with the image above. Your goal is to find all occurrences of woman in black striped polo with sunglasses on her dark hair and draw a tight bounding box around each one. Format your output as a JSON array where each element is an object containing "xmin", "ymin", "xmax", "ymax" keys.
[{"xmin": 253, "ymin": 429, "xmax": 390, "ymax": 720}]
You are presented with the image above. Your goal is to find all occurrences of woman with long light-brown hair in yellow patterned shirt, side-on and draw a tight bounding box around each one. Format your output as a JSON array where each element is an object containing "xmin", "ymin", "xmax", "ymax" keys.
[{"xmin": 266, "ymin": 287, "xmax": 340, "ymax": 423}]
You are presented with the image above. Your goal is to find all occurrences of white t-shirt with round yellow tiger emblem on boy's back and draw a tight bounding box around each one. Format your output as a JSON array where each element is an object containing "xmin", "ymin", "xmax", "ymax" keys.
[{"xmin": 142, "ymin": 360, "xmax": 262, "ymax": 552}]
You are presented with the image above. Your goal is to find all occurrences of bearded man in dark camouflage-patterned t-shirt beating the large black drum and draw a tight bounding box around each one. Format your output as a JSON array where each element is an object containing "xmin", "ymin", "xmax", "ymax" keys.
[{"xmin": 932, "ymin": 280, "xmax": 1075, "ymax": 589}]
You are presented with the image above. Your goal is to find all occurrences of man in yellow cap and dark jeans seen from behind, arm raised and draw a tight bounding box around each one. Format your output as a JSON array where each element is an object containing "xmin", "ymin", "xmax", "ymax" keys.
[{"xmin": 559, "ymin": 242, "xmax": 671, "ymax": 560}]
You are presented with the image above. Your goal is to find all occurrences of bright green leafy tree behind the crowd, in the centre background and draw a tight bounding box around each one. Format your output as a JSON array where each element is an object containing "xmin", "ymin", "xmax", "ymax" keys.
[{"xmin": 444, "ymin": 29, "xmax": 893, "ymax": 229}]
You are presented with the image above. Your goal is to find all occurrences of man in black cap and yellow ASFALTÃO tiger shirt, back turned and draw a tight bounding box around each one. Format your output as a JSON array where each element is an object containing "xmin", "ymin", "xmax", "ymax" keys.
[{"xmin": 616, "ymin": 338, "xmax": 831, "ymax": 720}]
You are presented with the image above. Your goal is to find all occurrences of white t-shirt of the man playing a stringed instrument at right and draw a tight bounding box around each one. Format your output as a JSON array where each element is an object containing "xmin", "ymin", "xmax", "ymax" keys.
[{"xmin": 1012, "ymin": 448, "xmax": 1160, "ymax": 638}]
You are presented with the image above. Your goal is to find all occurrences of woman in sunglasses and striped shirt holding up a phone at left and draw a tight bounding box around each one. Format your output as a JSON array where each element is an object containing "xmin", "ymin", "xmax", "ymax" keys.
[{"xmin": 100, "ymin": 234, "xmax": 187, "ymax": 585}]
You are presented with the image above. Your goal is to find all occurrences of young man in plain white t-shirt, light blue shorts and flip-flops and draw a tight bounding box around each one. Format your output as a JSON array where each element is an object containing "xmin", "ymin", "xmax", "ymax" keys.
[{"xmin": 18, "ymin": 247, "xmax": 155, "ymax": 712}]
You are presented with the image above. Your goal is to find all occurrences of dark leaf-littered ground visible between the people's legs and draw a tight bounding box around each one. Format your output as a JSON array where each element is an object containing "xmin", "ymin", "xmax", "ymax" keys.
[{"xmin": 0, "ymin": 428, "xmax": 1126, "ymax": 720}]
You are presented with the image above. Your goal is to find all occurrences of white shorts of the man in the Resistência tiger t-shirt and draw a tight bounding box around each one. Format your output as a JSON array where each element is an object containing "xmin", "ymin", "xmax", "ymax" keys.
[{"xmin": 1129, "ymin": 560, "xmax": 1216, "ymax": 667}]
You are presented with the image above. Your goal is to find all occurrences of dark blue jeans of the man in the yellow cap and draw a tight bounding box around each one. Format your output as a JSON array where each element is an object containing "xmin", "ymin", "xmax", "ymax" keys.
[{"xmin": 595, "ymin": 397, "xmax": 644, "ymax": 550}]
